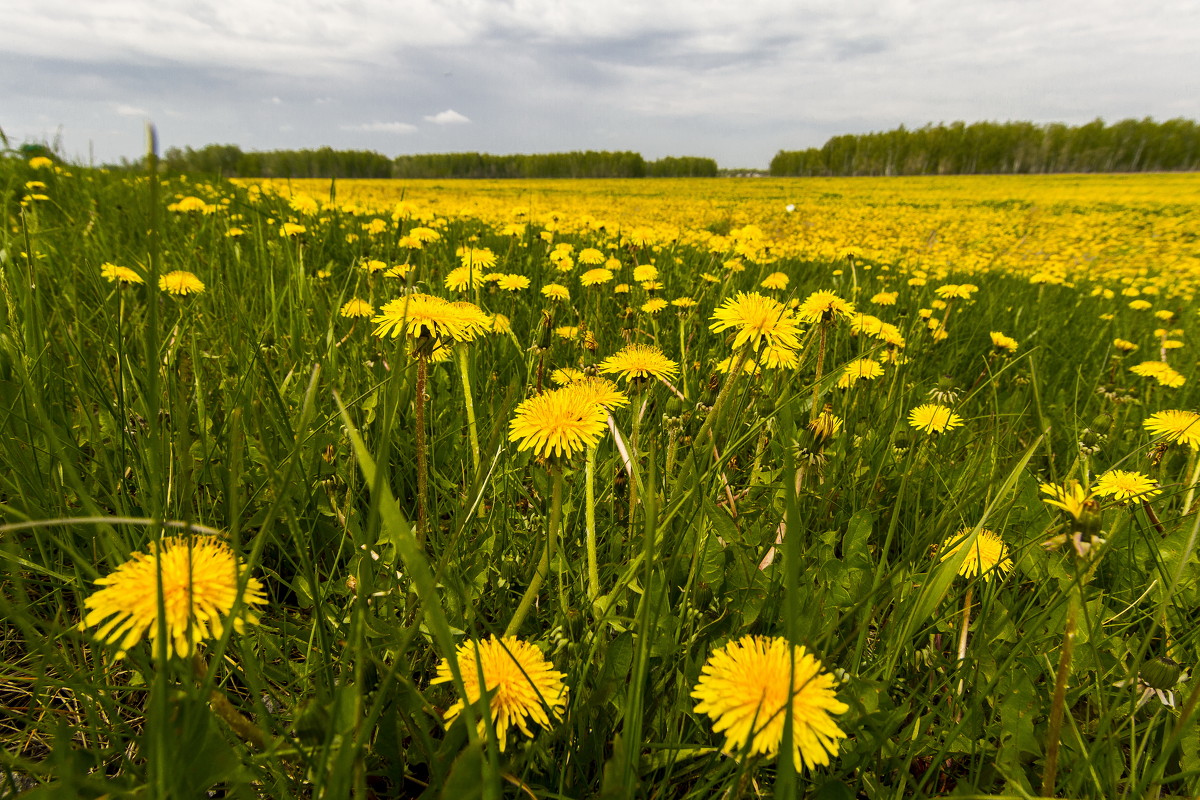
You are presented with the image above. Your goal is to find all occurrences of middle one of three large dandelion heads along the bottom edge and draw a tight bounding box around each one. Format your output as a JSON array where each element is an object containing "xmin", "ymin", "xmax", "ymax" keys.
[{"xmin": 430, "ymin": 636, "xmax": 566, "ymax": 752}]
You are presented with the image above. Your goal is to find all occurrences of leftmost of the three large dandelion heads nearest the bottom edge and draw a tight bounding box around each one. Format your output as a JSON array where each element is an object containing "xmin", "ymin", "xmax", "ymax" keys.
[{"xmin": 80, "ymin": 536, "xmax": 266, "ymax": 658}]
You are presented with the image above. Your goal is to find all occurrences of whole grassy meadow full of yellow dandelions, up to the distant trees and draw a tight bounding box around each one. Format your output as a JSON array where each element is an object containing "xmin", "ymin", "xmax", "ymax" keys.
[{"xmin": 0, "ymin": 153, "xmax": 1200, "ymax": 800}]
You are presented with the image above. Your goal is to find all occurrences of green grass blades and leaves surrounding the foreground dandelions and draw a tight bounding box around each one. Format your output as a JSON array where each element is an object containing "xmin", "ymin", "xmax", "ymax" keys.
[{"xmin": 0, "ymin": 146, "xmax": 1200, "ymax": 800}]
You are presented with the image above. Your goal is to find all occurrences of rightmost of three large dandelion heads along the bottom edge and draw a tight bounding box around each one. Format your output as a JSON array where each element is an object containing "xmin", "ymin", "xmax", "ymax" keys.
[{"xmin": 691, "ymin": 636, "xmax": 850, "ymax": 770}]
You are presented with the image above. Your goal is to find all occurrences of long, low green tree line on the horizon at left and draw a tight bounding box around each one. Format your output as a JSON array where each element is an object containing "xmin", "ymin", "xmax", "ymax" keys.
[{"xmin": 147, "ymin": 144, "xmax": 718, "ymax": 178}]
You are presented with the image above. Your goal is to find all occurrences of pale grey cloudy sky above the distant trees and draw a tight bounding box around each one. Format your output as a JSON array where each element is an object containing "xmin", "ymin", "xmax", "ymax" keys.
[{"xmin": 0, "ymin": 0, "xmax": 1200, "ymax": 168}]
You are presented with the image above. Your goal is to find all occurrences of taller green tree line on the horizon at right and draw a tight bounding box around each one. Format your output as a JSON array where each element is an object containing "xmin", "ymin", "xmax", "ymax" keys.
[{"xmin": 770, "ymin": 118, "xmax": 1200, "ymax": 176}]
